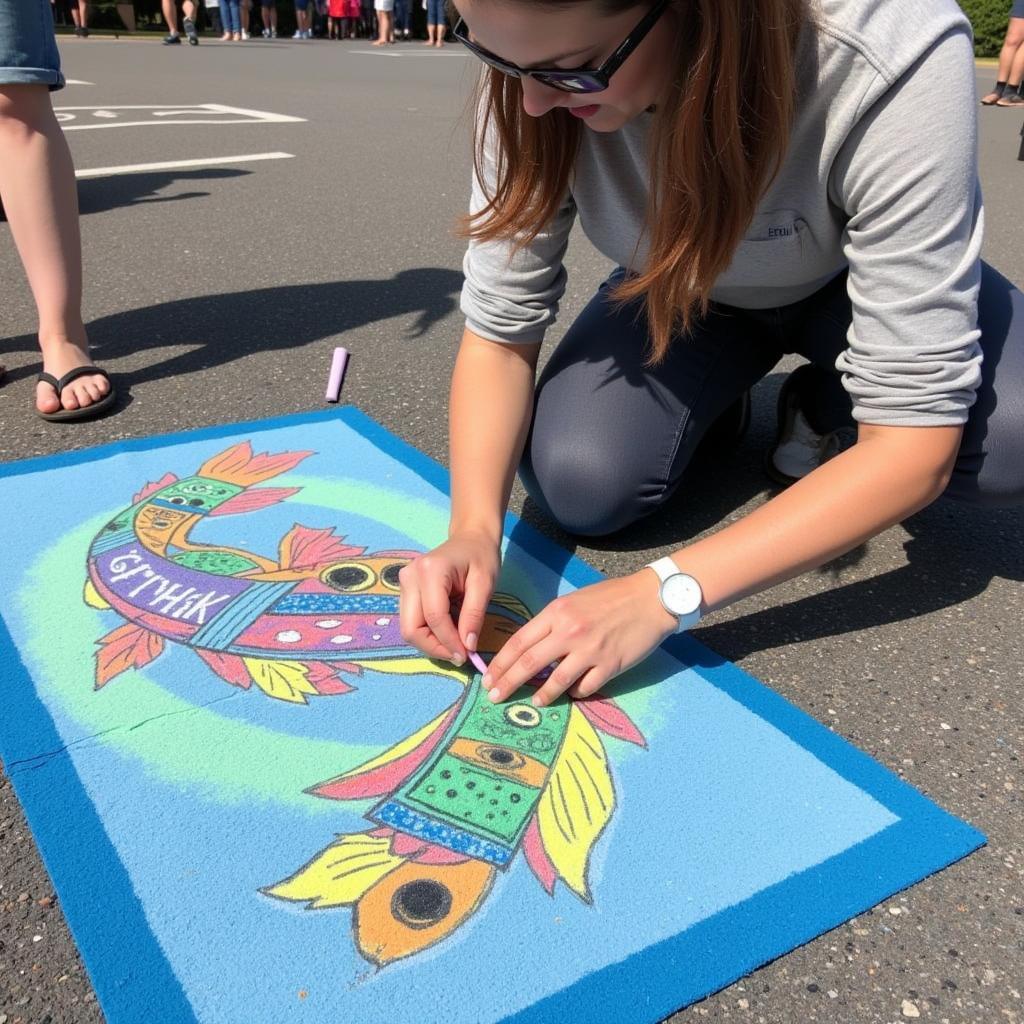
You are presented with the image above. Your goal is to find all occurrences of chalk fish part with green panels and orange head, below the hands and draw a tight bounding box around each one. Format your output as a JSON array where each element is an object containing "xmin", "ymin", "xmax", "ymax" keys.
[{"xmin": 263, "ymin": 675, "xmax": 646, "ymax": 968}]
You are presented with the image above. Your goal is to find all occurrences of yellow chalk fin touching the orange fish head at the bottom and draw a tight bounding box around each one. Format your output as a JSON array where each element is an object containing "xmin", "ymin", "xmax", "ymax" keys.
[{"xmin": 261, "ymin": 833, "xmax": 406, "ymax": 909}]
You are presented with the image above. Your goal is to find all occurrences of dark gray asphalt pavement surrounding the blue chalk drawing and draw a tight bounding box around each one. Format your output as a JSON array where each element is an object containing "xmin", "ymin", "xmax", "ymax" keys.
[{"xmin": 0, "ymin": 36, "xmax": 1024, "ymax": 1024}]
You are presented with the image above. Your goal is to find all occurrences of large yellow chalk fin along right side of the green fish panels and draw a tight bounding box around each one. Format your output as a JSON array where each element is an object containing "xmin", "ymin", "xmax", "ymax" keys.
[{"xmin": 537, "ymin": 703, "xmax": 615, "ymax": 903}]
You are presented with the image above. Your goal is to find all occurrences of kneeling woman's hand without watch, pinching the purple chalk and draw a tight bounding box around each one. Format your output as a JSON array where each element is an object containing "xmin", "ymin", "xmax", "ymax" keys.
[{"xmin": 398, "ymin": 534, "xmax": 501, "ymax": 666}]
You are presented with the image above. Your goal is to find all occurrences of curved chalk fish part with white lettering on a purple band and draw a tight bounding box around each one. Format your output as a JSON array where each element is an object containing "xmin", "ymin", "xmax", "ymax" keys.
[{"xmin": 85, "ymin": 441, "xmax": 529, "ymax": 703}]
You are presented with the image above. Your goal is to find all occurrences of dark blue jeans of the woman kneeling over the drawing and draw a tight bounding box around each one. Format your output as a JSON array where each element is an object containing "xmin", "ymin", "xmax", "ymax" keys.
[{"xmin": 519, "ymin": 265, "xmax": 1024, "ymax": 537}]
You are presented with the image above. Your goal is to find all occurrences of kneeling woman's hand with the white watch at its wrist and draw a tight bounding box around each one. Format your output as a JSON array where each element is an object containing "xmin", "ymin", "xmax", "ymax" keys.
[{"xmin": 483, "ymin": 567, "xmax": 678, "ymax": 707}]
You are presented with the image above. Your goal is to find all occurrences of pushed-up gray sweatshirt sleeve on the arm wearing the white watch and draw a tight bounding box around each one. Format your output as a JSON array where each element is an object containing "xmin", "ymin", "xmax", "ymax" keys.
[{"xmin": 831, "ymin": 29, "xmax": 983, "ymax": 426}]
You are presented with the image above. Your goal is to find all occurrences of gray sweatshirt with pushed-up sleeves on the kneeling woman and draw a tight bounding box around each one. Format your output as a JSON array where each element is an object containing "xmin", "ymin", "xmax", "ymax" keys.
[{"xmin": 462, "ymin": 0, "xmax": 983, "ymax": 426}]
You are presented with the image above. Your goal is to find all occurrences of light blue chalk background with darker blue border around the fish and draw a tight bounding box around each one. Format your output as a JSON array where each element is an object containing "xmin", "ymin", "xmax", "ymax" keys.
[{"xmin": 0, "ymin": 408, "xmax": 984, "ymax": 1024}]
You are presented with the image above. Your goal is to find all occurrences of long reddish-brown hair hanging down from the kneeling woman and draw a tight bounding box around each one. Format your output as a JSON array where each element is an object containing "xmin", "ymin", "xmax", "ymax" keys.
[{"xmin": 459, "ymin": 0, "xmax": 809, "ymax": 364}]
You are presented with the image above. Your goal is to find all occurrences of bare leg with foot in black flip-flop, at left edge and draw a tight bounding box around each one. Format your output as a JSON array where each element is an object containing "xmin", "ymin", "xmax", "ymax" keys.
[{"xmin": 0, "ymin": 85, "xmax": 110, "ymax": 413}]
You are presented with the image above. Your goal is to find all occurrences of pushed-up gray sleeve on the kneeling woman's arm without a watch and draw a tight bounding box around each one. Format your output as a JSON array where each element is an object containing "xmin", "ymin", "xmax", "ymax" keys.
[{"xmin": 461, "ymin": 111, "xmax": 575, "ymax": 344}]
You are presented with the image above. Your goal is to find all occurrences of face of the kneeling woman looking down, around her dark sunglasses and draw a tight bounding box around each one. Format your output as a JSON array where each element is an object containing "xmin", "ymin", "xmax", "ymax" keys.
[{"xmin": 458, "ymin": 0, "xmax": 676, "ymax": 131}]
